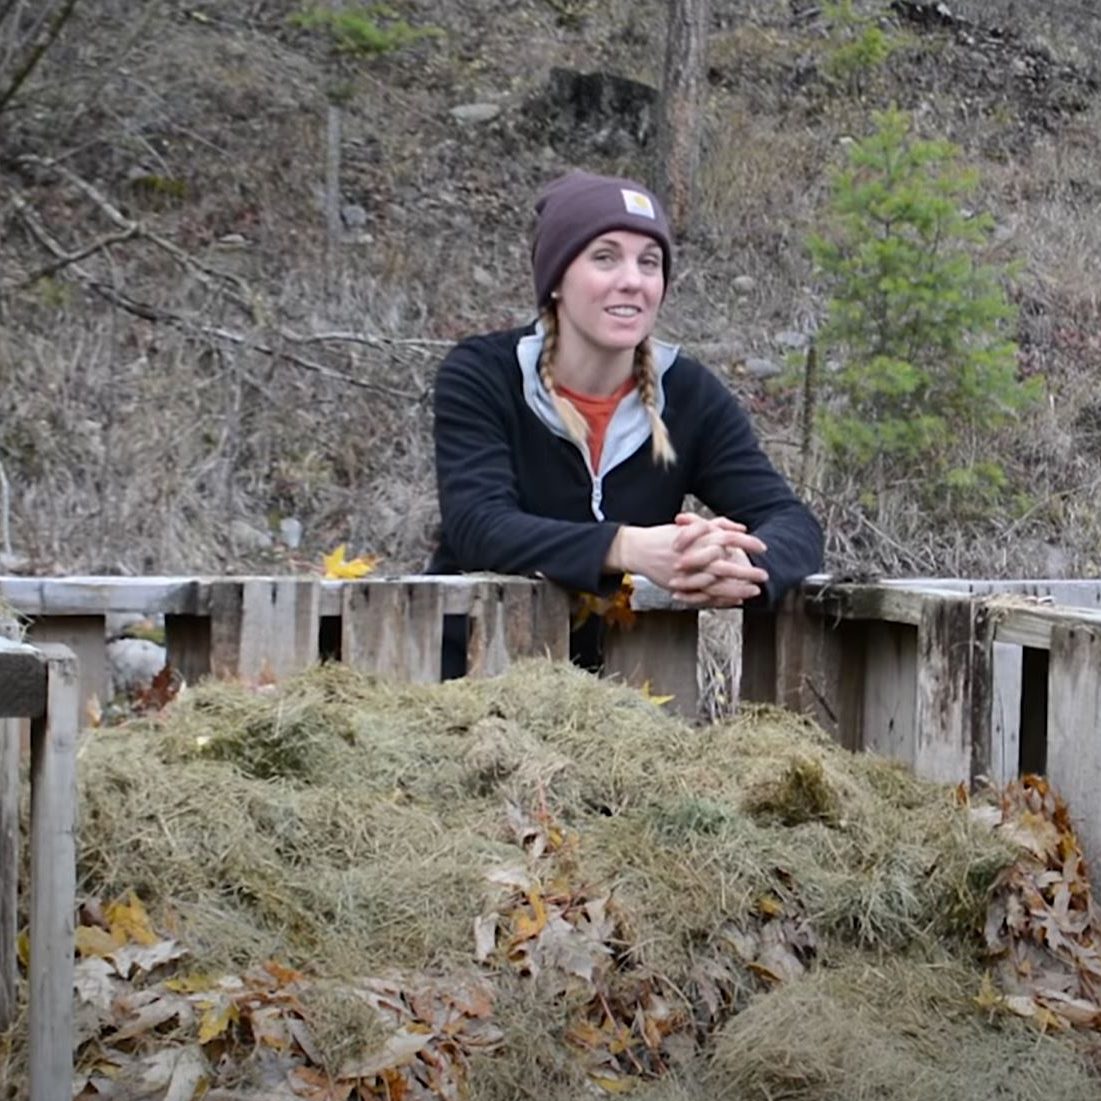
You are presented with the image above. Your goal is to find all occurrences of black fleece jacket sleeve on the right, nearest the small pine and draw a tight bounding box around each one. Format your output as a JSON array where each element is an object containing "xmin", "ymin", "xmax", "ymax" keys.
[{"xmin": 691, "ymin": 364, "xmax": 824, "ymax": 604}]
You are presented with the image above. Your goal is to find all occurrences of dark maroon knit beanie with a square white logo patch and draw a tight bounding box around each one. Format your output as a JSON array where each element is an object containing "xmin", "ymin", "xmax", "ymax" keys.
[{"xmin": 532, "ymin": 172, "xmax": 673, "ymax": 309}]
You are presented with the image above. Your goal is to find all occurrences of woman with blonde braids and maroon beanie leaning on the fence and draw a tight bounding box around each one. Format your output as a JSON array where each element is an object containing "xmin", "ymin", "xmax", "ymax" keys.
[{"xmin": 429, "ymin": 172, "xmax": 822, "ymax": 665}]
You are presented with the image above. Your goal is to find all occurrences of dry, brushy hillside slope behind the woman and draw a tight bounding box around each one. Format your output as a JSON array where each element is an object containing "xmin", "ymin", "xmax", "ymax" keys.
[{"xmin": 0, "ymin": 0, "xmax": 1101, "ymax": 575}]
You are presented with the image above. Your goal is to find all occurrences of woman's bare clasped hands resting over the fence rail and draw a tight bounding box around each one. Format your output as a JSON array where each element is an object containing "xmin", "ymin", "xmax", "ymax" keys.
[{"xmin": 608, "ymin": 512, "xmax": 768, "ymax": 608}]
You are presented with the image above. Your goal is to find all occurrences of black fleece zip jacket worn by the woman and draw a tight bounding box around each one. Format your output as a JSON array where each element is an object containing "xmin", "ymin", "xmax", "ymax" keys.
[{"xmin": 429, "ymin": 327, "xmax": 822, "ymax": 603}]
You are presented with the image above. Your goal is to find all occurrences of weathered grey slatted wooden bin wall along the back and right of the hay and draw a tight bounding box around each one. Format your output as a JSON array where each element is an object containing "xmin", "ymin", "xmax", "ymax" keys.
[{"xmin": 0, "ymin": 575, "xmax": 1101, "ymax": 853}]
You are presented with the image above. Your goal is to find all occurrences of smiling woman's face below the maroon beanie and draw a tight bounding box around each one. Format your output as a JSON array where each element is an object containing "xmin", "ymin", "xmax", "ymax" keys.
[{"xmin": 558, "ymin": 230, "xmax": 665, "ymax": 352}]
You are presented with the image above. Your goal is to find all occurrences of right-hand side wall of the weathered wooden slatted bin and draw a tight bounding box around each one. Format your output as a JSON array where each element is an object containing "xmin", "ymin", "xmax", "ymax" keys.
[{"xmin": 743, "ymin": 581, "xmax": 1101, "ymax": 882}]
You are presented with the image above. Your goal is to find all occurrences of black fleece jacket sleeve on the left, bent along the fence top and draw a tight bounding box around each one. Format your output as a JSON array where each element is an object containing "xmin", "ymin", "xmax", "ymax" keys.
[{"xmin": 434, "ymin": 341, "xmax": 619, "ymax": 592}]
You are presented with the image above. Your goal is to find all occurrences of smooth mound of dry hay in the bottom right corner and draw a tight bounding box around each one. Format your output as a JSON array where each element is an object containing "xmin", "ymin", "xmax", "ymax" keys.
[{"xmin": 706, "ymin": 948, "xmax": 1098, "ymax": 1101}]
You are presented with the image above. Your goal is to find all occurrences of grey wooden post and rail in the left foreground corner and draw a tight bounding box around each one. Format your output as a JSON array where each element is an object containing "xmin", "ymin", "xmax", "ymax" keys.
[{"xmin": 0, "ymin": 631, "xmax": 79, "ymax": 1101}]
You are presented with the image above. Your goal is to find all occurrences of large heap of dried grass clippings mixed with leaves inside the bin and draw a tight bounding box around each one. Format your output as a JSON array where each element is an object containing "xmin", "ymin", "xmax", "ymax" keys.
[{"xmin": 64, "ymin": 663, "xmax": 1098, "ymax": 1101}]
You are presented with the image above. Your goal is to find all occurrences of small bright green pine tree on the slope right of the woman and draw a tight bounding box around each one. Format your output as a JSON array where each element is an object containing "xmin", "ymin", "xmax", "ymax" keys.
[{"xmin": 810, "ymin": 109, "xmax": 1043, "ymax": 509}]
